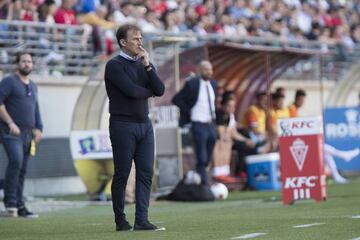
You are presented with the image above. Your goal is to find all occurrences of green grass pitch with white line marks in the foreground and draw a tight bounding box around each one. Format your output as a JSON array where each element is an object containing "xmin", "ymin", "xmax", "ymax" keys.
[{"xmin": 0, "ymin": 178, "xmax": 360, "ymax": 240}]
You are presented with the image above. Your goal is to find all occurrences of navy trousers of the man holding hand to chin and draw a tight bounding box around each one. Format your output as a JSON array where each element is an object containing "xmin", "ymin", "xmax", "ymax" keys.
[{"xmin": 110, "ymin": 119, "xmax": 154, "ymax": 224}]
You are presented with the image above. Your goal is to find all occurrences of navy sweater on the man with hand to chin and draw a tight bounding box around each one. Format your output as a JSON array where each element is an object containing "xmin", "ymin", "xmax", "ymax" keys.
[{"xmin": 105, "ymin": 55, "xmax": 165, "ymax": 122}]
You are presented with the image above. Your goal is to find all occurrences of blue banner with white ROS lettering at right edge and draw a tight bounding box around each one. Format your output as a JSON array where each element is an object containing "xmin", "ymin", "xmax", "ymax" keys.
[{"xmin": 324, "ymin": 107, "xmax": 360, "ymax": 173}]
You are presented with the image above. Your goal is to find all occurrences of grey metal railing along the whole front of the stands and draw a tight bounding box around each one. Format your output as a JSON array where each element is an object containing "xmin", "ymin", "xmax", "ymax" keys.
[{"xmin": 0, "ymin": 20, "xmax": 360, "ymax": 80}]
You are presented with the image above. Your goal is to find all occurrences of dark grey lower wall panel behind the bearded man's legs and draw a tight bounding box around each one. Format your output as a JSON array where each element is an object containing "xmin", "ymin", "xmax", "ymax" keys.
[{"xmin": 0, "ymin": 138, "xmax": 77, "ymax": 178}]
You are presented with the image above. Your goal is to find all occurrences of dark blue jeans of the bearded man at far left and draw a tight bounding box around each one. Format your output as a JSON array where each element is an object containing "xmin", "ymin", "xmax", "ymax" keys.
[{"xmin": 1, "ymin": 130, "xmax": 32, "ymax": 208}]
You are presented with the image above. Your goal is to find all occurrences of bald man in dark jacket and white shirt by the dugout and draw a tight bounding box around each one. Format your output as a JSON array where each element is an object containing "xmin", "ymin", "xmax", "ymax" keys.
[{"xmin": 172, "ymin": 61, "xmax": 217, "ymax": 184}]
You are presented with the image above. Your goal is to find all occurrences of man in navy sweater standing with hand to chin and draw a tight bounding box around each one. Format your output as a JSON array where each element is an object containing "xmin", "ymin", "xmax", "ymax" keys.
[{"xmin": 105, "ymin": 25, "xmax": 165, "ymax": 231}]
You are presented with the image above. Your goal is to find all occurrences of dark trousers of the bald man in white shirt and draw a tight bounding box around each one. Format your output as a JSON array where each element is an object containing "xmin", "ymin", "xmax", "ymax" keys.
[{"xmin": 191, "ymin": 122, "xmax": 217, "ymax": 184}]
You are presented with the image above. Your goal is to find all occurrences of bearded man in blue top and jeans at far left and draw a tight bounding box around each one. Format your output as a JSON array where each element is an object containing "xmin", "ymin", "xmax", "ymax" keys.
[{"xmin": 0, "ymin": 52, "xmax": 43, "ymax": 217}]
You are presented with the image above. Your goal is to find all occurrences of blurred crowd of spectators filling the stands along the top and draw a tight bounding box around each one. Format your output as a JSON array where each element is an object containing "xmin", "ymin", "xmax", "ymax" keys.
[{"xmin": 0, "ymin": 0, "xmax": 360, "ymax": 45}]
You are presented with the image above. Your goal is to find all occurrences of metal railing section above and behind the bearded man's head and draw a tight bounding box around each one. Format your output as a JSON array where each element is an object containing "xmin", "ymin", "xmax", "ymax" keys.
[{"xmin": 0, "ymin": 21, "xmax": 97, "ymax": 75}]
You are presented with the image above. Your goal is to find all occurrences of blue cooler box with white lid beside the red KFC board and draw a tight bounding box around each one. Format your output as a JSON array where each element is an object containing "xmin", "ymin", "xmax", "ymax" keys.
[{"xmin": 246, "ymin": 153, "xmax": 281, "ymax": 190}]
